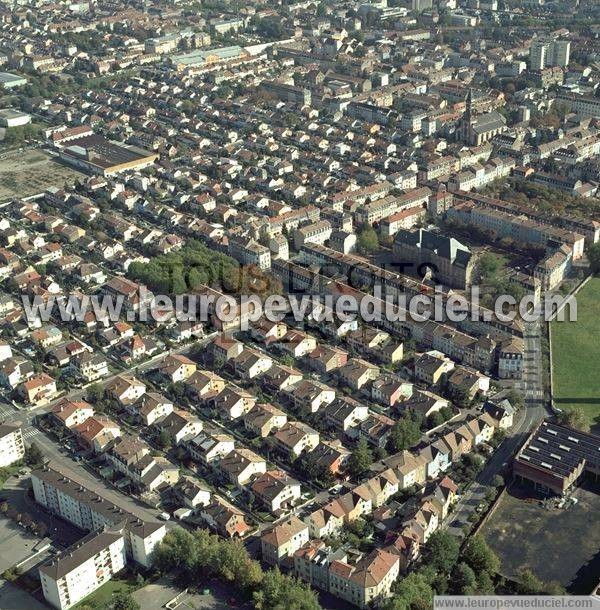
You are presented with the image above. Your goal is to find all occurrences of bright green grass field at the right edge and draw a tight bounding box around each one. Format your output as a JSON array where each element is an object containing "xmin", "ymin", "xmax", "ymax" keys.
[{"xmin": 552, "ymin": 278, "xmax": 600, "ymax": 427}]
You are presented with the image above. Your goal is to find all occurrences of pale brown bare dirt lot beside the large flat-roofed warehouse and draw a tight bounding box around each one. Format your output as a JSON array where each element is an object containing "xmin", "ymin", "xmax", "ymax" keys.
[{"xmin": 0, "ymin": 149, "xmax": 83, "ymax": 203}]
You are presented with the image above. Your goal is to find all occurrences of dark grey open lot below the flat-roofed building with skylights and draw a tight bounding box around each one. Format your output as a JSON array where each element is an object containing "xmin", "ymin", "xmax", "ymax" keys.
[{"xmin": 481, "ymin": 485, "xmax": 600, "ymax": 594}]
